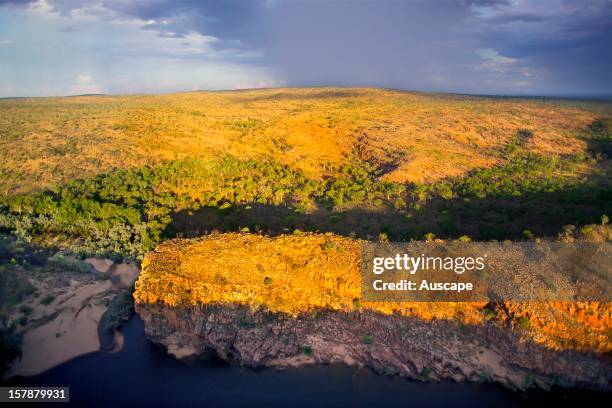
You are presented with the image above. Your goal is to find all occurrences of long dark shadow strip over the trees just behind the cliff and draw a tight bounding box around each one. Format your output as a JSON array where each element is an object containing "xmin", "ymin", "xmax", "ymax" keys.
[{"xmin": 163, "ymin": 180, "xmax": 612, "ymax": 240}]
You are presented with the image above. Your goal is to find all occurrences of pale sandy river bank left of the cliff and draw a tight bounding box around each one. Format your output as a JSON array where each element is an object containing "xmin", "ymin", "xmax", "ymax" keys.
[{"xmin": 5, "ymin": 257, "xmax": 139, "ymax": 378}]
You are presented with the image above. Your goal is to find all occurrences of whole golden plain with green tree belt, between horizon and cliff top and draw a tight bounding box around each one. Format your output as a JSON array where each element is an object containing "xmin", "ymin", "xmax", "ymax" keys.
[{"xmin": 0, "ymin": 88, "xmax": 612, "ymax": 260}]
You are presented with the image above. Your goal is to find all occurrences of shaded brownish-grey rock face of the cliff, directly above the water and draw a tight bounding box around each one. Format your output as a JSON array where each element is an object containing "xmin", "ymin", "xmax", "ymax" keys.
[{"xmin": 136, "ymin": 304, "xmax": 610, "ymax": 389}]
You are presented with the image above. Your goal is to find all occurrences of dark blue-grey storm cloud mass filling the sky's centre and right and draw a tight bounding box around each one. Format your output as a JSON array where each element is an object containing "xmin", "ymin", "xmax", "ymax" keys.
[{"xmin": 0, "ymin": 0, "xmax": 612, "ymax": 93}]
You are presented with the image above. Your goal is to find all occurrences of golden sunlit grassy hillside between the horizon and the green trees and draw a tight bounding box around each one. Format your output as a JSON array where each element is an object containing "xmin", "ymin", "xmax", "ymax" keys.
[{"xmin": 0, "ymin": 88, "xmax": 612, "ymax": 194}]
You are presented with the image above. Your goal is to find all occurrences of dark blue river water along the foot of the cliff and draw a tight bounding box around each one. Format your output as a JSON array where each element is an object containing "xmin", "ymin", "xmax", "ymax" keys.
[{"xmin": 2, "ymin": 317, "xmax": 610, "ymax": 407}]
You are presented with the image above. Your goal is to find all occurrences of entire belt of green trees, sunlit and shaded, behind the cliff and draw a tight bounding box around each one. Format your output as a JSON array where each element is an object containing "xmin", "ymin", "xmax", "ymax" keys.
[{"xmin": 0, "ymin": 120, "xmax": 612, "ymax": 258}]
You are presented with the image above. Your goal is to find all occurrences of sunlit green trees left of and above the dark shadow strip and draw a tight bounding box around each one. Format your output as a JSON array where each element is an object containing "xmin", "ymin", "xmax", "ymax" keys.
[{"xmin": 0, "ymin": 158, "xmax": 401, "ymax": 257}]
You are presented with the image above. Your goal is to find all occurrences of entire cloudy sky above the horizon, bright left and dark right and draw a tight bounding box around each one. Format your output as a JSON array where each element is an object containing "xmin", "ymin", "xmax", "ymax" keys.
[{"xmin": 0, "ymin": 0, "xmax": 612, "ymax": 97}]
